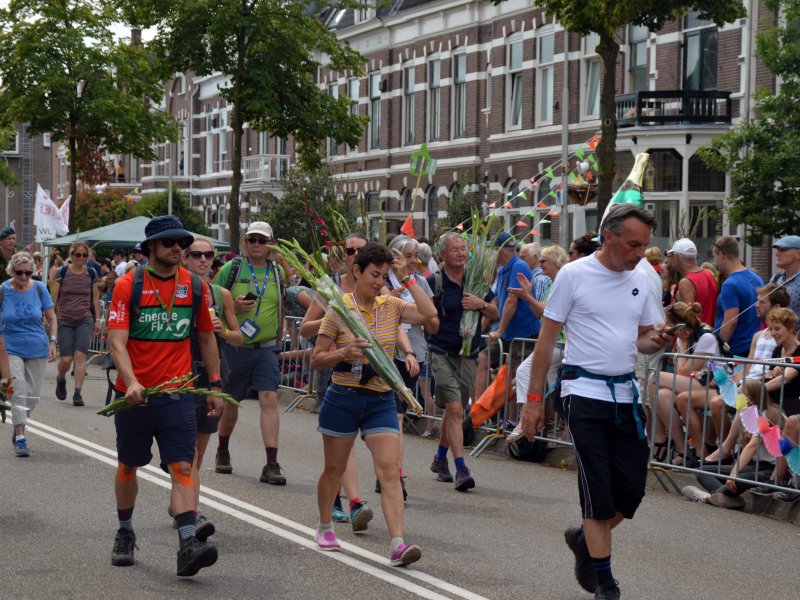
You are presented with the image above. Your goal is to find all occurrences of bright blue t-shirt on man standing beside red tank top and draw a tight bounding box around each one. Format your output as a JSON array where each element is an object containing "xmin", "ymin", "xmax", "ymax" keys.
[{"xmin": 714, "ymin": 269, "xmax": 764, "ymax": 356}]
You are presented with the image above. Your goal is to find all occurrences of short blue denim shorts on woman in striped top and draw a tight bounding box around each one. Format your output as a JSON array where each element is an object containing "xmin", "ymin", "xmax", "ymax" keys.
[{"xmin": 317, "ymin": 383, "xmax": 400, "ymax": 438}]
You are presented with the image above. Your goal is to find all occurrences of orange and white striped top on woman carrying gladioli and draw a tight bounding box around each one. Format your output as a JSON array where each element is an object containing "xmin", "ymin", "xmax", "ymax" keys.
[{"xmin": 319, "ymin": 294, "xmax": 408, "ymax": 392}]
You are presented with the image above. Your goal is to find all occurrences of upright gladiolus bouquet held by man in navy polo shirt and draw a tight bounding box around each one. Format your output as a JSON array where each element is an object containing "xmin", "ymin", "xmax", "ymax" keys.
[{"xmin": 460, "ymin": 211, "xmax": 504, "ymax": 356}]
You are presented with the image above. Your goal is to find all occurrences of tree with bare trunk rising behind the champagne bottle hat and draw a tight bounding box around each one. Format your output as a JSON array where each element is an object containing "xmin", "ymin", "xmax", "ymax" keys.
[{"xmin": 494, "ymin": 0, "xmax": 745, "ymax": 214}]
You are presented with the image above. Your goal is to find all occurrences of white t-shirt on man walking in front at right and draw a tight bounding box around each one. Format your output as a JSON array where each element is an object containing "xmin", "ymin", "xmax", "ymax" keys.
[{"xmin": 544, "ymin": 254, "xmax": 657, "ymax": 402}]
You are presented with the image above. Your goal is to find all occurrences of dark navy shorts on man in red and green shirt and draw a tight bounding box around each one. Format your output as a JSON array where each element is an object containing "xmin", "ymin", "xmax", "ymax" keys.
[{"xmin": 114, "ymin": 392, "xmax": 197, "ymax": 467}]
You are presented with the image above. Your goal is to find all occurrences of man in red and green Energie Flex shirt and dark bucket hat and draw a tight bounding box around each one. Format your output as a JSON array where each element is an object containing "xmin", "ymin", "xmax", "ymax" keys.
[{"xmin": 108, "ymin": 215, "xmax": 222, "ymax": 576}]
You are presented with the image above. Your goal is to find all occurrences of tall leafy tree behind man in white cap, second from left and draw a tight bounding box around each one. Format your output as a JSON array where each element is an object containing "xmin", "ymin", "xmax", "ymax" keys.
[{"xmin": 126, "ymin": 0, "xmax": 365, "ymax": 248}]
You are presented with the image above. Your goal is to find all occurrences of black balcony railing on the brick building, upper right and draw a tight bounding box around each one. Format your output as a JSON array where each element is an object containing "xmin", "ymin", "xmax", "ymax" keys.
[{"xmin": 616, "ymin": 90, "xmax": 731, "ymax": 127}]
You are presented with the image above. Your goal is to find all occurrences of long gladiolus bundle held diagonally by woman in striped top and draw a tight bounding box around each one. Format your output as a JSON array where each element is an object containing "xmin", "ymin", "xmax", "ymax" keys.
[{"xmin": 278, "ymin": 240, "xmax": 423, "ymax": 415}]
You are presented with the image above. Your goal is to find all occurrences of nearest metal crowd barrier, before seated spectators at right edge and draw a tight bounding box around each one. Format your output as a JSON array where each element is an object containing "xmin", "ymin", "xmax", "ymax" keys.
[{"xmin": 646, "ymin": 353, "xmax": 800, "ymax": 494}]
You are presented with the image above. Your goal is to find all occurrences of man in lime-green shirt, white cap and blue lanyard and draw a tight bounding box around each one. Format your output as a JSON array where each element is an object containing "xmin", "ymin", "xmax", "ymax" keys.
[{"xmin": 214, "ymin": 221, "xmax": 286, "ymax": 485}]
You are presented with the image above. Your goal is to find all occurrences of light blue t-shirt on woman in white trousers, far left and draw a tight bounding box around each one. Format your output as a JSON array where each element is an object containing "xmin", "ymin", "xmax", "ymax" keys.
[{"xmin": 0, "ymin": 281, "xmax": 53, "ymax": 358}]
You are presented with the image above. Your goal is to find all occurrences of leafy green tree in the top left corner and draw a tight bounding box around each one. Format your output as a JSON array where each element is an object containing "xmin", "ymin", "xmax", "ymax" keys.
[{"xmin": 0, "ymin": 0, "xmax": 178, "ymax": 229}]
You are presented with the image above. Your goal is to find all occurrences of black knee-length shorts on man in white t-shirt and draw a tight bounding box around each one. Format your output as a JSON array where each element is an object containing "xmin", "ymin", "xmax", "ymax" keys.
[{"xmin": 559, "ymin": 394, "xmax": 650, "ymax": 520}]
